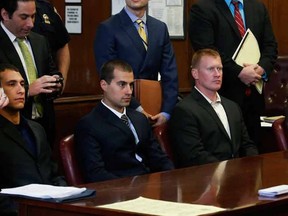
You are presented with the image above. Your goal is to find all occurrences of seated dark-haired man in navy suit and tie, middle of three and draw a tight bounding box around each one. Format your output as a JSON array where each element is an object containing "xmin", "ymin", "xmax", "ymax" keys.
[{"xmin": 75, "ymin": 60, "xmax": 173, "ymax": 182}]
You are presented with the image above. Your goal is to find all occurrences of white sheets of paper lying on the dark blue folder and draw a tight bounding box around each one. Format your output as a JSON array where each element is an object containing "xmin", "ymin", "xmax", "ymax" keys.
[{"xmin": 0, "ymin": 184, "xmax": 86, "ymax": 199}]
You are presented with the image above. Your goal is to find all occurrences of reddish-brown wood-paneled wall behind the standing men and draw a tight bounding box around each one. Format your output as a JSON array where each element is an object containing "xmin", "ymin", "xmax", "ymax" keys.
[{"xmin": 51, "ymin": 0, "xmax": 288, "ymax": 95}]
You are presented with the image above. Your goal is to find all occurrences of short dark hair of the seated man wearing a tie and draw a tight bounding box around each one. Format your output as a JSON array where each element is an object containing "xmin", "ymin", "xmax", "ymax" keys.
[{"xmin": 100, "ymin": 59, "xmax": 133, "ymax": 84}]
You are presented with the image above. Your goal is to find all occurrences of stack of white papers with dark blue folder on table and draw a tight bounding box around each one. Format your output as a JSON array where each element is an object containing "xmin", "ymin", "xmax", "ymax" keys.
[{"xmin": 0, "ymin": 184, "xmax": 95, "ymax": 202}]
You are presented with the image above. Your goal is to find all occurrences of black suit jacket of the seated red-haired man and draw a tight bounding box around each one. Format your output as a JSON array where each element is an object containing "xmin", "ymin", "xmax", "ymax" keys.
[{"xmin": 169, "ymin": 88, "xmax": 258, "ymax": 167}]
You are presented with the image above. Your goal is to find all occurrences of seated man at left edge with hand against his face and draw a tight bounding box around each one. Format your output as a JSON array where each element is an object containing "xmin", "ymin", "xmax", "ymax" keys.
[{"xmin": 0, "ymin": 64, "xmax": 66, "ymax": 216}]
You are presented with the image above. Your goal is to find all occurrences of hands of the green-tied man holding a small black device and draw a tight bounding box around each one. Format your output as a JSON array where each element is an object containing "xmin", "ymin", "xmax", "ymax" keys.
[{"xmin": 29, "ymin": 75, "xmax": 62, "ymax": 96}]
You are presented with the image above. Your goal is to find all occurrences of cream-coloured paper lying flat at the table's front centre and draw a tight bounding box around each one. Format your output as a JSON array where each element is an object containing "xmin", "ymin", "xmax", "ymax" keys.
[{"xmin": 97, "ymin": 197, "xmax": 226, "ymax": 216}]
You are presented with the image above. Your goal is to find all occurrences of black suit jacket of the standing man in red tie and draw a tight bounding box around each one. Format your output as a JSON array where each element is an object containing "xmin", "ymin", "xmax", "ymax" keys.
[{"xmin": 189, "ymin": 0, "xmax": 277, "ymax": 108}]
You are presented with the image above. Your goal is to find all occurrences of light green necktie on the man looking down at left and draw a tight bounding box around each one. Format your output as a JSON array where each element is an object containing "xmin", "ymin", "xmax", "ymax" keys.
[{"xmin": 16, "ymin": 38, "xmax": 43, "ymax": 117}]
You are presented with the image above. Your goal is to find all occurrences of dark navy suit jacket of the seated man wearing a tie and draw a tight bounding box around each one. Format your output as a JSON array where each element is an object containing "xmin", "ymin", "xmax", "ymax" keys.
[{"xmin": 75, "ymin": 103, "xmax": 173, "ymax": 182}]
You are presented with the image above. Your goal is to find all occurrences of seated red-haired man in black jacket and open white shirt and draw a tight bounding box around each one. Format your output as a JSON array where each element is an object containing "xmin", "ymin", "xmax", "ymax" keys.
[{"xmin": 169, "ymin": 49, "xmax": 258, "ymax": 167}]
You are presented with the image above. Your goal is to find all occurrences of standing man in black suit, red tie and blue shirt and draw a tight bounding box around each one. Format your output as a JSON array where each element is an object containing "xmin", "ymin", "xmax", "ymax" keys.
[{"xmin": 189, "ymin": 0, "xmax": 277, "ymax": 145}]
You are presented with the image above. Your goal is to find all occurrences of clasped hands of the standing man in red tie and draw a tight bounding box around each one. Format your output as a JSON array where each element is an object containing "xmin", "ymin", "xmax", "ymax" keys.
[{"xmin": 238, "ymin": 63, "xmax": 264, "ymax": 86}]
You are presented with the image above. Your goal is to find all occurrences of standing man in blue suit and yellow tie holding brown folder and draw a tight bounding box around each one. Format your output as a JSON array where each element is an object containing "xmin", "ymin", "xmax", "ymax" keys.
[{"xmin": 94, "ymin": 0, "xmax": 178, "ymax": 126}]
